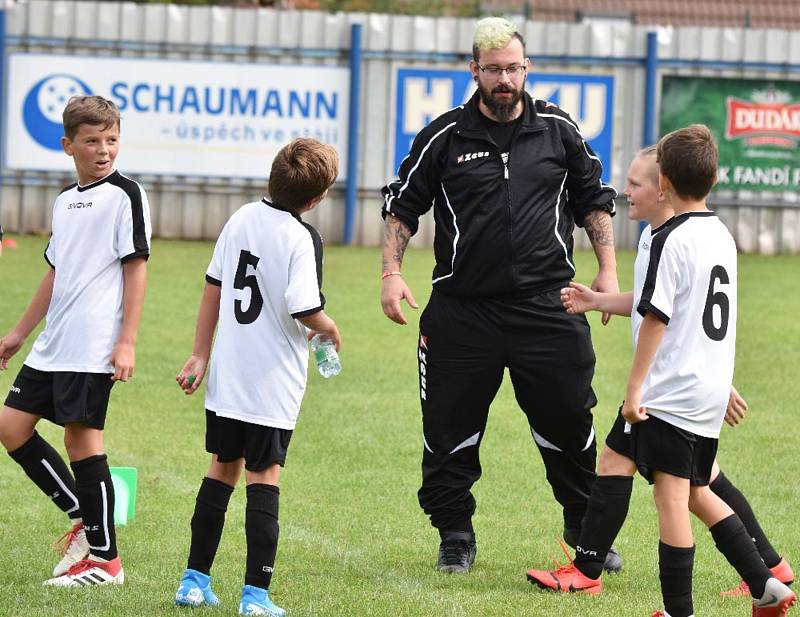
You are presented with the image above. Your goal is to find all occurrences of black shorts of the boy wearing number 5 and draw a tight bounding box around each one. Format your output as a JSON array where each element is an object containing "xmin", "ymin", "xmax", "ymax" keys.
[{"xmin": 206, "ymin": 409, "xmax": 292, "ymax": 471}]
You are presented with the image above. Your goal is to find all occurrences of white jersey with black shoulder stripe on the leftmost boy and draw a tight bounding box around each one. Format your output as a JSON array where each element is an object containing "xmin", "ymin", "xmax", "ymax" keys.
[{"xmin": 25, "ymin": 171, "xmax": 151, "ymax": 373}]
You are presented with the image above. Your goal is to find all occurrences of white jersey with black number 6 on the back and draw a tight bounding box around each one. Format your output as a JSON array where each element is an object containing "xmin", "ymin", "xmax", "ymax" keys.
[{"xmin": 631, "ymin": 211, "xmax": 737, "ymax": 438}]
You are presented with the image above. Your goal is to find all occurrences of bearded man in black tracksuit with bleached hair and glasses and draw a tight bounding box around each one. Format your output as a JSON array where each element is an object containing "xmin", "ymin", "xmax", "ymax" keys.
[{"xmin": 381, "ymin": 18, "xmax": 621, "ymax": 572}]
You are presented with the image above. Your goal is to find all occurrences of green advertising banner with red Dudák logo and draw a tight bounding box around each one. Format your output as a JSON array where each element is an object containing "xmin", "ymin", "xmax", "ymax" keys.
[{"xmin": 661, "ymin": 76, "xmax": 800, "ymax": 191}]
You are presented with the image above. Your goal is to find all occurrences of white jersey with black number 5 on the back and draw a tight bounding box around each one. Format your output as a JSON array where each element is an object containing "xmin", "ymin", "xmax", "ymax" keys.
[{"xmin": 206, "ymin": 199, "xmax": 325, "ymax": 429}]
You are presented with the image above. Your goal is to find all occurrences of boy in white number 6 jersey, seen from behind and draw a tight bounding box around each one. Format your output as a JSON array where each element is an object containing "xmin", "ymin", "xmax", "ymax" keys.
[{"xmin": 622, "ymin": 125, "xmax": 796, "ymax": 617}]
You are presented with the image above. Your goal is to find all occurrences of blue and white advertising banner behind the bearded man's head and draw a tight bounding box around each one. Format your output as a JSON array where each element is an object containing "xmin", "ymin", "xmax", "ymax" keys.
[{"xmin": 394, "ymin": 69, "xmax": 614, "ymax": 183}]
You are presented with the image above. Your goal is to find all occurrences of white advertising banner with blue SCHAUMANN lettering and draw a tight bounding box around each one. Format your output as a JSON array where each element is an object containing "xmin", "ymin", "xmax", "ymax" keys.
[{"xmin": 4, "ymin": 53, "xmax": 350, "ymax": 180}]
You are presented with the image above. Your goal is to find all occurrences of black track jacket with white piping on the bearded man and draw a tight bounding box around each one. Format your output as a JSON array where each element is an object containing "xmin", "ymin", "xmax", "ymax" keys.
[{"xmin": 382, "ymin": 91, "xmax": 616, "ymax": 297}]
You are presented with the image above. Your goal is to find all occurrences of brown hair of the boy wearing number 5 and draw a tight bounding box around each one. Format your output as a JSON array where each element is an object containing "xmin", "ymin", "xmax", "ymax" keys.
[{"xmin": 267, "ymin": 137, "xmax": 339, "ymax": 212}]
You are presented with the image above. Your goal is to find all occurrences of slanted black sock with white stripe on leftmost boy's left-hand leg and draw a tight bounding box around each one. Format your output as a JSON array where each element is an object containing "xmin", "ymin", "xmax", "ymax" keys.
[{"xmin": 8, "ymin": 431, "xmax": 81, "ymax": 518}]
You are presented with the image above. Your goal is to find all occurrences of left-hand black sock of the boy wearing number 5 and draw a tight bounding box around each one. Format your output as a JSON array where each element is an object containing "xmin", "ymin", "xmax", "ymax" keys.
[{"xmin": 186, "ymin": 478, "xmax": 233, "ymax": 574}]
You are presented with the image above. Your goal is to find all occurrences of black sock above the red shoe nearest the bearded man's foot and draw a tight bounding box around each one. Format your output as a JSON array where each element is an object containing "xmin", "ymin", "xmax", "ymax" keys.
[{"xmin": 574, "ymin": 476, "xmax": 633, "ymax": 578}]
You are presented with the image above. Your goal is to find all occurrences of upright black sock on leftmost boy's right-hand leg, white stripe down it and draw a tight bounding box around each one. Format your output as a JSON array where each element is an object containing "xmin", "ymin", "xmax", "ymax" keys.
[{"xmin": 70, "ymin": 454, "xmax": 117, "ymax": 561}]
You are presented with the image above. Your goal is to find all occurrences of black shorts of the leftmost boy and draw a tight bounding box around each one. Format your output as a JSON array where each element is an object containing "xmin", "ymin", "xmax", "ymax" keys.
[{"xmin": 5, "ymin": 364, "xmax": 114, "ymax": 430}]
